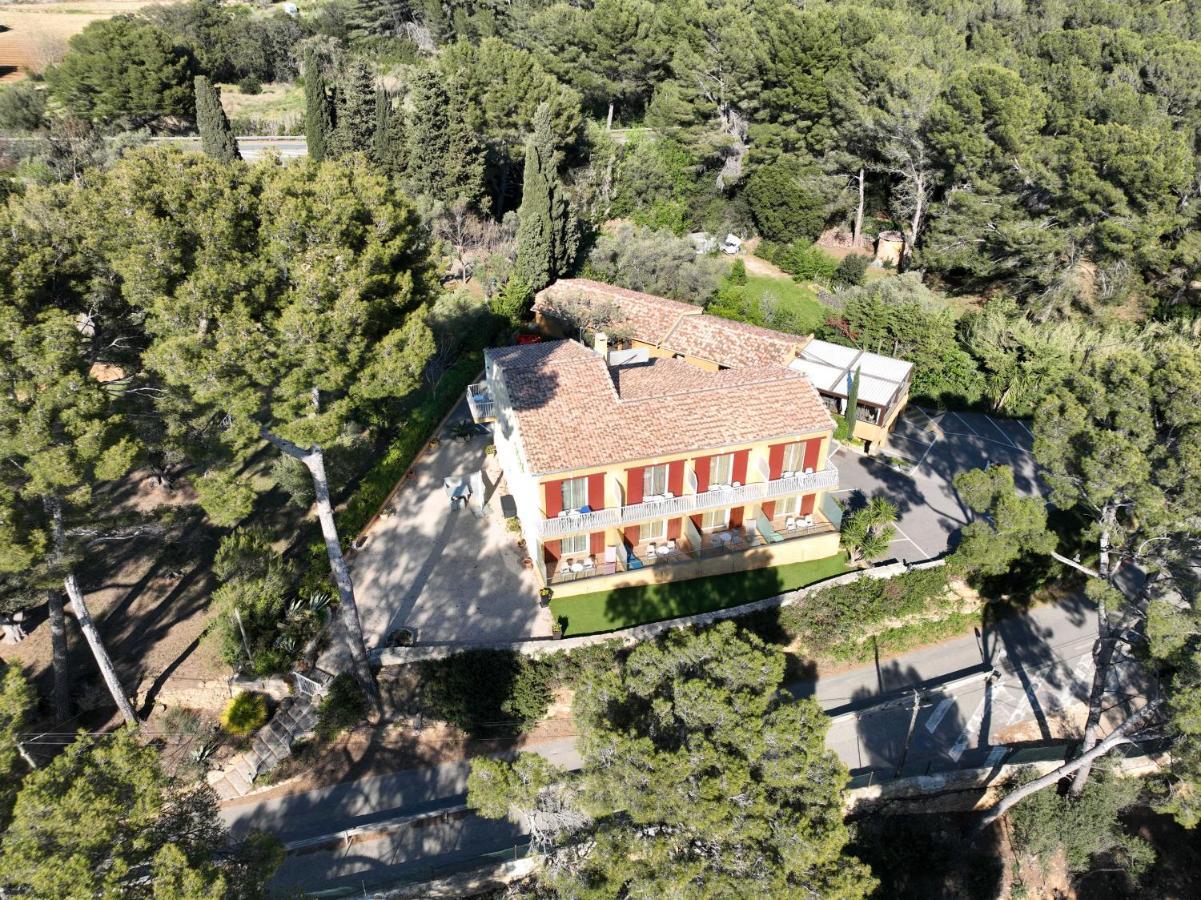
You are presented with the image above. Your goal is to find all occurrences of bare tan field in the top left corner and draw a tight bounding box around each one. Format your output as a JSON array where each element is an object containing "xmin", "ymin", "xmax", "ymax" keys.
[{"xmin": 0, "ymin": 0, "xmax": 169, "ymax": 81}]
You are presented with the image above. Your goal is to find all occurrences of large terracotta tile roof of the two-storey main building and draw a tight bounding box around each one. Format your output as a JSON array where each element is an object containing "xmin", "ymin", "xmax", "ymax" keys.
[{"xmin": 488, "ymin": 341, "xmax": 833, "ymax": 475}]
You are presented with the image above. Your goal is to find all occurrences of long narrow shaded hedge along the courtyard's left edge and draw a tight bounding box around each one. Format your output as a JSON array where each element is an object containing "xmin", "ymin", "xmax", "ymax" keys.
[{"xmin": 337, "ymin": 353, "xmax": 484, "ymax": 547}]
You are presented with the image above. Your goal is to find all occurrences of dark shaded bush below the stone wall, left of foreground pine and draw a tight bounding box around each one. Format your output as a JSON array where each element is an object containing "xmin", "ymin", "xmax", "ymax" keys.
[{"xmin": 422, "ymin": 650, "xmax": 554, "ymax": 737}]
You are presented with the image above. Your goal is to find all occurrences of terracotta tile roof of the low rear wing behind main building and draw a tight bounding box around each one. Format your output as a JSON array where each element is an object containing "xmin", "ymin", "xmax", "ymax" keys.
[{"xmin": 533, "ymin": 279, "xmax": 807, "ymax": 368}]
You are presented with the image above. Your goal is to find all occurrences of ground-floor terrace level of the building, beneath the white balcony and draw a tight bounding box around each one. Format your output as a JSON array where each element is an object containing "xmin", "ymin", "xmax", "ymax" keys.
[{"xmin": 540, "ymin": 494, "xmax": 842, "ymax": 596}]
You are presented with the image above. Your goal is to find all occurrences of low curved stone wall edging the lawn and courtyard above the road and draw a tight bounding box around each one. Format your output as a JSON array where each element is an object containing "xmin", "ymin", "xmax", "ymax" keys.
[{"xmin": 371, "ymin": 560, "xmax": 945, "ymax": 666}]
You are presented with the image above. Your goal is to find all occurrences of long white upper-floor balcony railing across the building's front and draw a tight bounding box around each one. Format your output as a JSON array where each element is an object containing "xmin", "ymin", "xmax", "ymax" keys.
[{"xmin": 538, "ymin": 466, "xmax": 838, "ymax": 538}]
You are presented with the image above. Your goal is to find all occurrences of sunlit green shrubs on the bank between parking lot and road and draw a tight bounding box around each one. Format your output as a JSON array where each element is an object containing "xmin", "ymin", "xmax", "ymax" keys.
[{"xmin": 779, "ymin": 568, "xmax": 946, "ymax": 655}]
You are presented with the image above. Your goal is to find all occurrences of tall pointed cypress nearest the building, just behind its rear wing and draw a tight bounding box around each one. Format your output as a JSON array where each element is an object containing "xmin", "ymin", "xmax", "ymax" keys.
[{"xmin": 515, "ymin": 103, "xmax": 579, "ymax": 291}]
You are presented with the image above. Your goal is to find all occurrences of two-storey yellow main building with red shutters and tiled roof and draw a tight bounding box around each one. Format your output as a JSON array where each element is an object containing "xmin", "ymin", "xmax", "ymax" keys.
[{"xmin": 468, "ymin": 339, "xmax": 841, "ymax": 596}]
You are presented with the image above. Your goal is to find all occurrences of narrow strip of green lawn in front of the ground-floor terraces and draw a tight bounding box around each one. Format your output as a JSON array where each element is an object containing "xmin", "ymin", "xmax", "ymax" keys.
[{"xmin": 550, "ymin": 553, "xmax": 849, "ymax": 637}]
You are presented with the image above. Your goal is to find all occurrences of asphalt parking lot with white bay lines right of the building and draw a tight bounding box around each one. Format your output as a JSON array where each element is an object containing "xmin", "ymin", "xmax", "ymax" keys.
[{"xmin": 833, "ymin": 406, "xmax": 1039, "ymax": 562}]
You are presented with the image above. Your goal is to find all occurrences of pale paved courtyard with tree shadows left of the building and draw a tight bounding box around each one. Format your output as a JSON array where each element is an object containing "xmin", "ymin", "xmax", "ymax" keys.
[{"xmin": 351, "ymin": 401, "xmax": 550, "ymax": 650}]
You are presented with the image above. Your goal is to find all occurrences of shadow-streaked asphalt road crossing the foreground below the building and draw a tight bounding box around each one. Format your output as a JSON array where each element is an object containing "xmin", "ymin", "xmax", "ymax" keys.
[{"xmin": 222, "ymin": 601, "xmax": 1125, "ymax": 892}]
